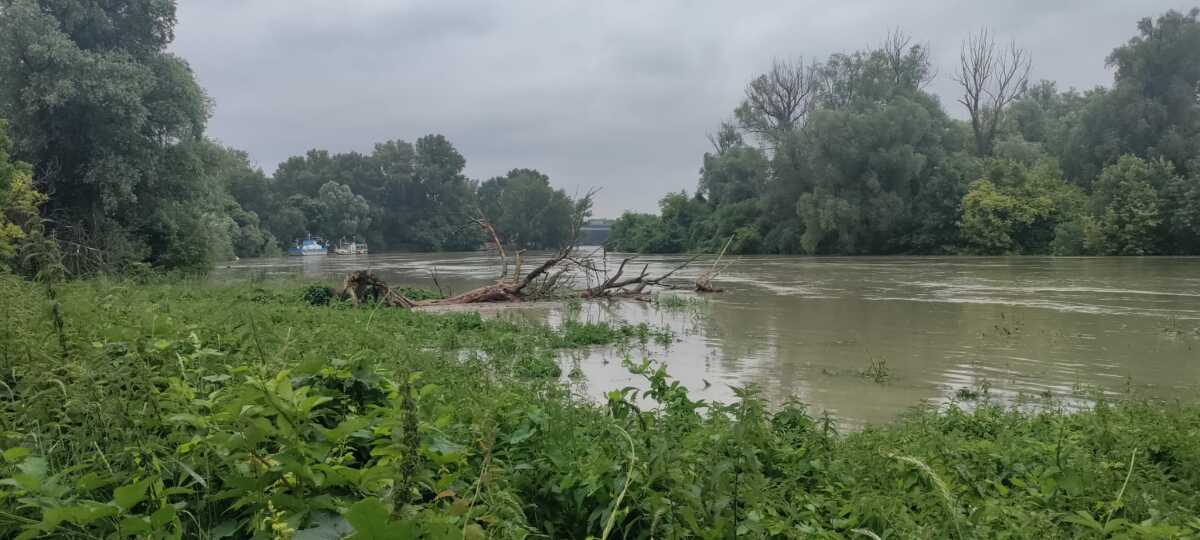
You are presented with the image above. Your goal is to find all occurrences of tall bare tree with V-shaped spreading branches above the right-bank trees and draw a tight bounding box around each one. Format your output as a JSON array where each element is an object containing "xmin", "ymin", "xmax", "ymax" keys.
[{"xmin": 954, "ymin": 29, "xmax": 1032, "ymax": 156}]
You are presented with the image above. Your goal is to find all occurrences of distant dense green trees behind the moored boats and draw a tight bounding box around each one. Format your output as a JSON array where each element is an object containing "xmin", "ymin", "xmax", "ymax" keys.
[{"xmin": 254, "ymin": 136, "xmax": 585, "ymax": 250}]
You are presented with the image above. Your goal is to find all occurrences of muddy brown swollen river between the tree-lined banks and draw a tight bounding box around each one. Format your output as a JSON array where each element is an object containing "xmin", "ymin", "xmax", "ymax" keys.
[{"xmin": 218, "ymin": 253, "xmax": 1200, "ymax": 427}]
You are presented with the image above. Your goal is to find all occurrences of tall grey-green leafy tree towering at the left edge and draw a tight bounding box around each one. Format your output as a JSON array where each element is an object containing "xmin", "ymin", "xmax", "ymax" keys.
[{"xmin": 0, "ymin": 0, "xmax": 209, "ymax": 266}]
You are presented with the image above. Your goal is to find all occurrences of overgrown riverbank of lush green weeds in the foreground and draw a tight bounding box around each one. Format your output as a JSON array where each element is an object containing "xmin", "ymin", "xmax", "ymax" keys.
[{"xmin": 0, "ymin": 276, "xmax": 1200, "ymax": 539}]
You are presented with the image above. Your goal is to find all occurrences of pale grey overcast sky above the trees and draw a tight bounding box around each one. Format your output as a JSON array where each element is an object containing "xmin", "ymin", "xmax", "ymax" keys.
[{"xmin": 174, "ymin": 0, "xmax": 1195, "ymax": 217}]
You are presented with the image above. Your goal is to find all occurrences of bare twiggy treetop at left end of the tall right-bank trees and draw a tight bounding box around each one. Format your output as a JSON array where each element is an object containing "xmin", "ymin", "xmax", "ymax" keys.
[{"xmin": 737, "ymin": 59, "xmax": 818, "ymax": 139}]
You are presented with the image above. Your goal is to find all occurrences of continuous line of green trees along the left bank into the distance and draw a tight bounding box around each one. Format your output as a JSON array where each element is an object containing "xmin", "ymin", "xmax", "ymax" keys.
[{"xmin": 0, "ymin": 0, "xmax": 574, "ymax": 274}]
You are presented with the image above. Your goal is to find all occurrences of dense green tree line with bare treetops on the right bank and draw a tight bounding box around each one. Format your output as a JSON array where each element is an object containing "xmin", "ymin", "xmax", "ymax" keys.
[{"xmin": 608, "ymin": 10, "xmax": 1200, "ymax": 254}]
